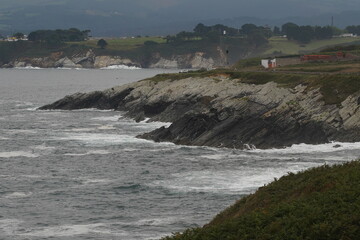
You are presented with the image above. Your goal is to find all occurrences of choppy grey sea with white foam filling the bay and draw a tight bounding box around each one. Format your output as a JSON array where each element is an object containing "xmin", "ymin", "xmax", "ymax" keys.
[{"xmin": 0, "ymin": 68, "xmax": 360, "ymax": 240}]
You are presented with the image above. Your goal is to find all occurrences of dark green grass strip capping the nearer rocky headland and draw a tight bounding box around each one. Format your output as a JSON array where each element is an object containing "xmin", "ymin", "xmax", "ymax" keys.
[{"xmin": 145, "ymin": 69, "xmax": 360, "ymax": 104}]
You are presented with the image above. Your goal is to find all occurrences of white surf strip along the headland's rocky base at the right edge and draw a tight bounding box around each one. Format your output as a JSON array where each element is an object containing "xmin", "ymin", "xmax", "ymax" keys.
[{"xmin": 252, "ymin": 142, "xmax": 360, "ymax": 154}]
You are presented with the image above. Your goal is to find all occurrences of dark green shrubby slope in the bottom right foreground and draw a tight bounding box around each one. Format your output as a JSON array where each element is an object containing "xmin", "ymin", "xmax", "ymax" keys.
[{"xmin": 163, "ymin": 161, "xmax": 360, "ymax": 240}]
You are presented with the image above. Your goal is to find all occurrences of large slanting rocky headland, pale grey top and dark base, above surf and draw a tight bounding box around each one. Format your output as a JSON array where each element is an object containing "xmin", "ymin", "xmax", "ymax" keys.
[{"xmin": 41, "ymin": 75, "xmax": 360, "ymax": 148}]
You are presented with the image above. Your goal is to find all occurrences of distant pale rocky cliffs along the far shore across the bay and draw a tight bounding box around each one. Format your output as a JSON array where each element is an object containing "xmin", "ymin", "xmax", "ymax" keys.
[{"xmin": 3, "ymin": 50, "xmax": 216, "ymax": 69}]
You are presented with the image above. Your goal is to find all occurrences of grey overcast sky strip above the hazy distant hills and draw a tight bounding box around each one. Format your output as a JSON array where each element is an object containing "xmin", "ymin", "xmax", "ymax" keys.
[{"xmin": 0, "ymin": 0, "xmax": 360, "ymax": 18}]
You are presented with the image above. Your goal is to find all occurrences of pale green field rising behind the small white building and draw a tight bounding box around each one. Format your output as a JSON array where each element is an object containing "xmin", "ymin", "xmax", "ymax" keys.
[{"xmin": 264, "ymin": 37, "xmax": 360, "ymax": 55}]
